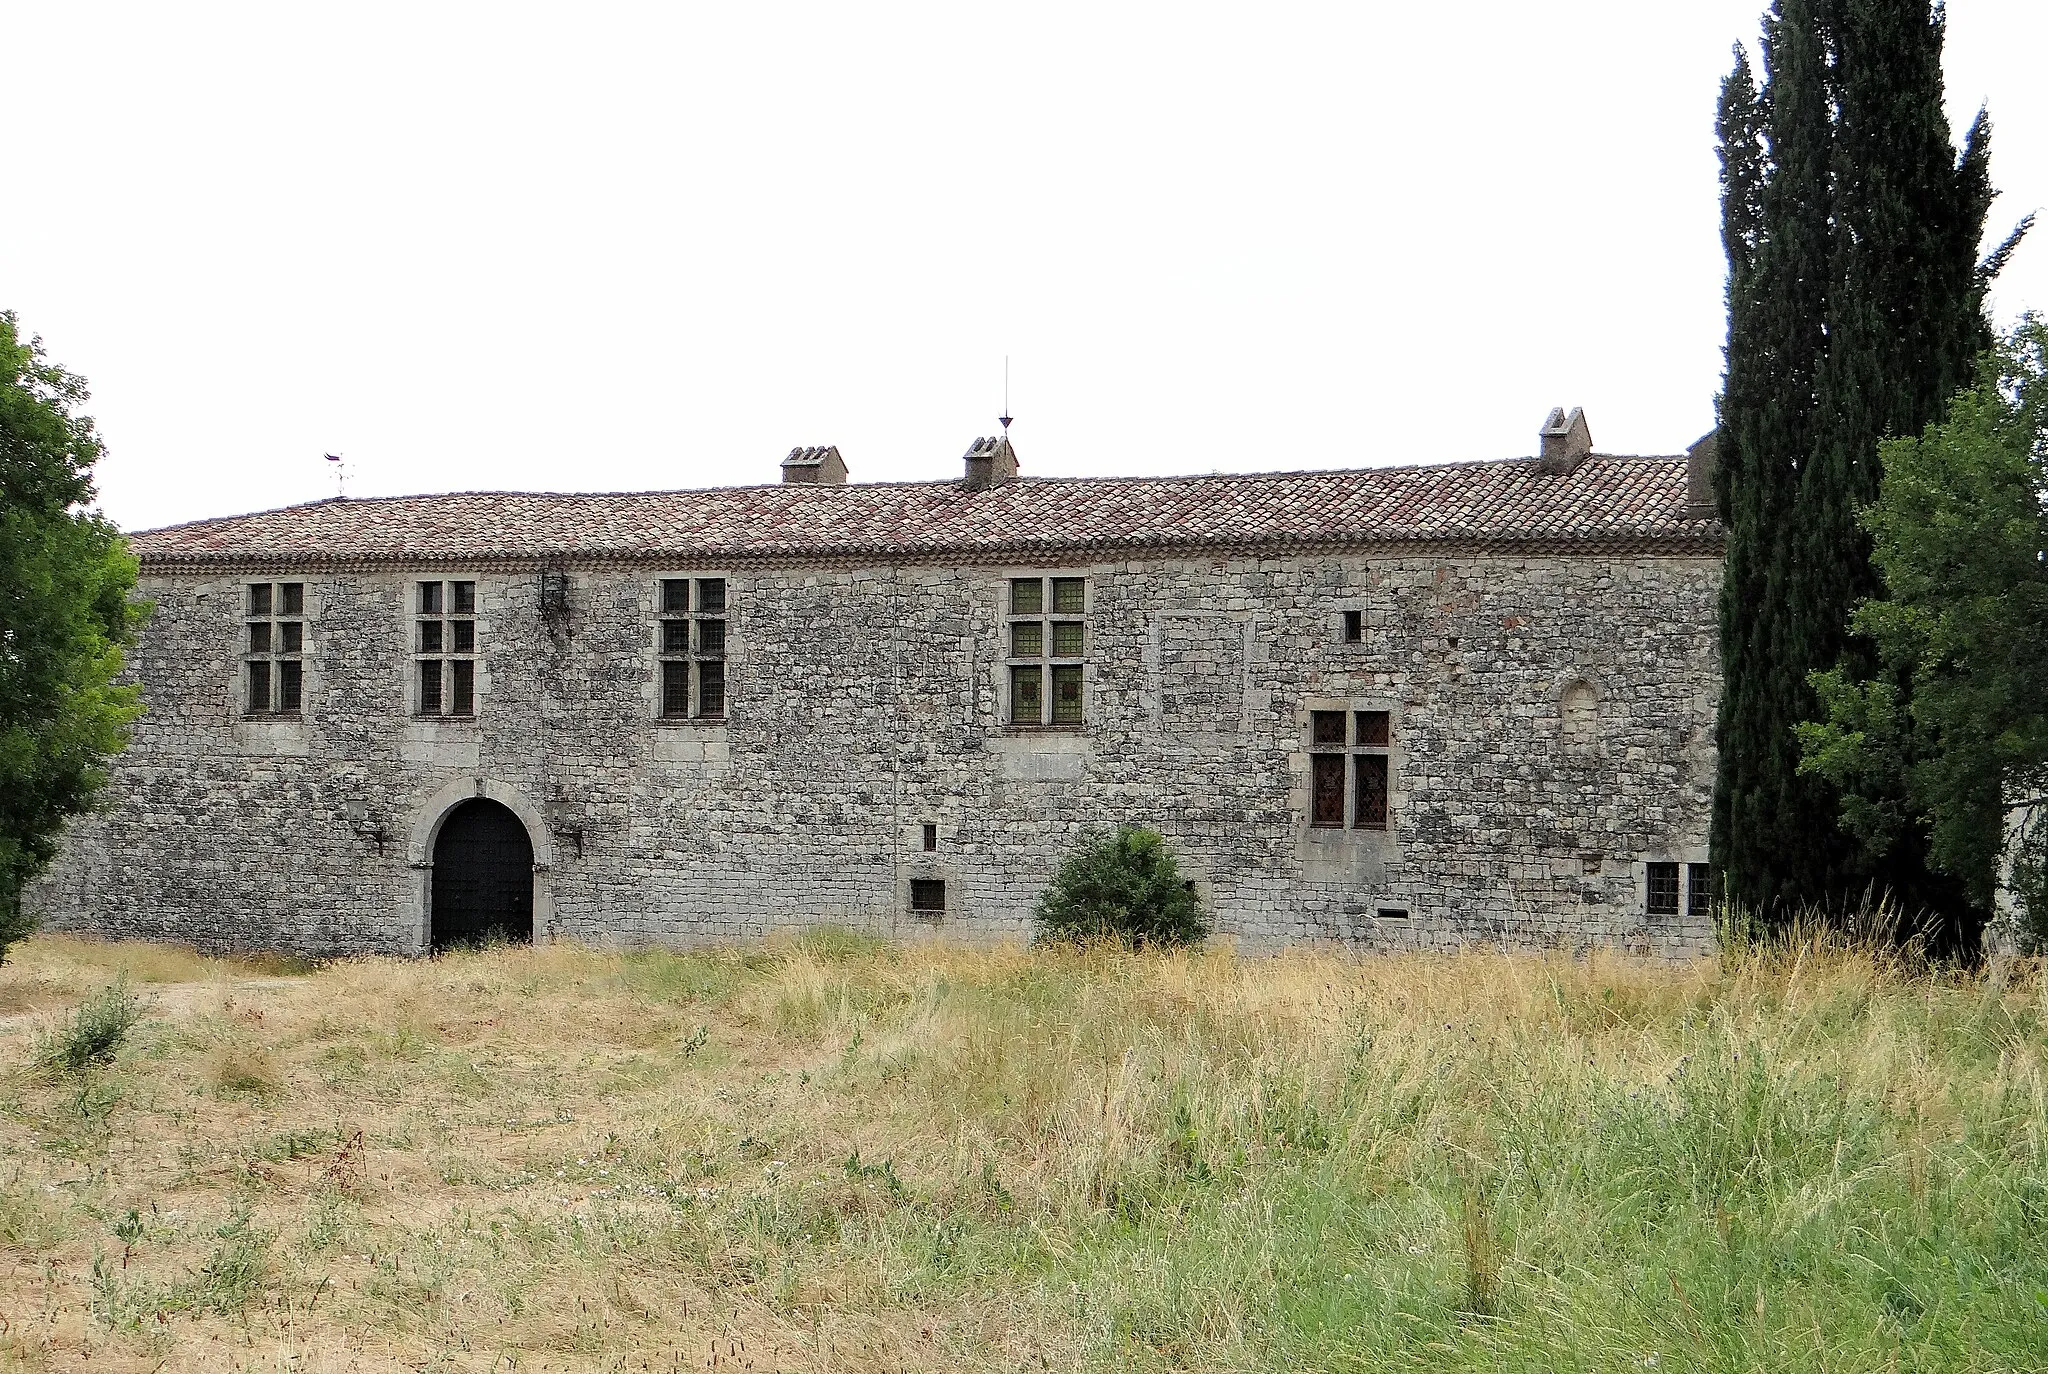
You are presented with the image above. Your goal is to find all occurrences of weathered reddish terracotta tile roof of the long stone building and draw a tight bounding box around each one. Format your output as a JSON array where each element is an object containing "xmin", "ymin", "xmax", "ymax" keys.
[{"xmin": 131, "ymin": 455, "xmax": 1722, "ymax": 571}]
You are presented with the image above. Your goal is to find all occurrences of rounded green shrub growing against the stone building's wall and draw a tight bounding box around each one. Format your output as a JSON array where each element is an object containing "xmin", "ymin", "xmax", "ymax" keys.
[{"xmin": 1034, "ymin": 825, "xmax": 1208, "ymax": 948}]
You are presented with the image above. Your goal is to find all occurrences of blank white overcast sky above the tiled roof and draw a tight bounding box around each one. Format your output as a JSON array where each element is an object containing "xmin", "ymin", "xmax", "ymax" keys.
[{"xmin": 0, "ymin": 0, "xmax": 2048, "ymax": 528}]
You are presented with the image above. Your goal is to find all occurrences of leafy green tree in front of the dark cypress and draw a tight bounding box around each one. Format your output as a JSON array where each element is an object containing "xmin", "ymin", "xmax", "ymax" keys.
[{"xmin": 1800, "ymin": 317, "xmax": 2048, "ymax": 950}]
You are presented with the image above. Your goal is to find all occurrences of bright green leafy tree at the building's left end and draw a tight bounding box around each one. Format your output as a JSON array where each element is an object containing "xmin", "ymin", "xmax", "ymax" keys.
[{"xmin": 0, "ymin": 311, "xmax": 143, "ymax": 960}]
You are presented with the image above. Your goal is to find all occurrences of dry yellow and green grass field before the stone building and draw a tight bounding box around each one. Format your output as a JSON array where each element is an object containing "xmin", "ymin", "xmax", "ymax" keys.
[{"xmin": 0, "ymin": 930, "xmax": 2048, "ymax": 1374}]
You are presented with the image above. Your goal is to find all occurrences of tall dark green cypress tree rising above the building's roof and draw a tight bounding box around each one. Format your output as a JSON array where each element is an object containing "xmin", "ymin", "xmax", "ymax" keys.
[{"xmin": 1714, "ymin": 0, "xmax": 2013, "ymax": 938}]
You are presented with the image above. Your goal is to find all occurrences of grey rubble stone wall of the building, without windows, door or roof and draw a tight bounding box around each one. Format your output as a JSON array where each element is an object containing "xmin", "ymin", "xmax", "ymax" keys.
[{"xmin": 33, "ymin": 555, "xmax": 1718, "ymax": 954}]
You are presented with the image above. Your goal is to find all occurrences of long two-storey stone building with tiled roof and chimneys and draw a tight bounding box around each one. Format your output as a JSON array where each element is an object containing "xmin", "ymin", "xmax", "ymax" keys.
[{"xmin": 31, "ymin": 412, "xmax": 1722, "ymax": 952}]
